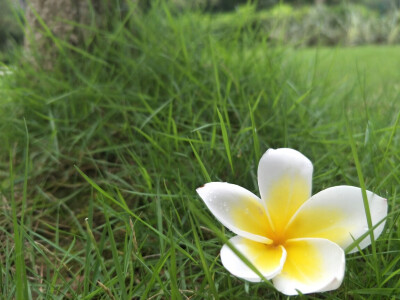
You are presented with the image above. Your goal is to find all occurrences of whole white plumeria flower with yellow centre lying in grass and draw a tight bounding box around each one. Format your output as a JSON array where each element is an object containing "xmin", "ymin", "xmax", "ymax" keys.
[{"xmin": 197, "ymin": 148, "xmax": 387, "ymax": 295}]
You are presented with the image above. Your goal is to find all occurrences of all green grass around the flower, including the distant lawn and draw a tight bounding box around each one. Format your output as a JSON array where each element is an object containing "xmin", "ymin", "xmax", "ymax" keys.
[{"xmin": 0, "ymin": 5, "xmax": 400, "ymax": 299}]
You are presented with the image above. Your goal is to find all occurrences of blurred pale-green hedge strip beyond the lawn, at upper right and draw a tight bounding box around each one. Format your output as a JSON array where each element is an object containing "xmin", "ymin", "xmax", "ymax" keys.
[{"xmin": 206, "ymin": 4, "xmax": 400, "ymax": 46}]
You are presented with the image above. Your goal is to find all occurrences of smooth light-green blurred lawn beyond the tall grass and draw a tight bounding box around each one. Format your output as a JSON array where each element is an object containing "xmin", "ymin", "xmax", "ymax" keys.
[{"xmin": 294, "ymin": 46, "xmax": 400, "ymax": 102}]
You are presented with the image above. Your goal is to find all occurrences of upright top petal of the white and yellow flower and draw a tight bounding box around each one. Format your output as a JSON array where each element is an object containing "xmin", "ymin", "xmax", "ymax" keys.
[{"xmin": 258, "ymin": 148, "xmax": 313, "ymax": 233}]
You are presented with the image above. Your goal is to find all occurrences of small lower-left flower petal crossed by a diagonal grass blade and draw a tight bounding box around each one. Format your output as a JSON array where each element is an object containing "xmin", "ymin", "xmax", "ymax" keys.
[{"xmin": 221, "ymin": 236, "xmax": 286, "ymax": 282}]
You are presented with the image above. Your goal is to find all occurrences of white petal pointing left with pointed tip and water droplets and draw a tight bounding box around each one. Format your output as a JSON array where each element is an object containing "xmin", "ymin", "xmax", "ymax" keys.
[{"xmin": 196, "ymin": 182, "xmax": 272, "ymax": 244}]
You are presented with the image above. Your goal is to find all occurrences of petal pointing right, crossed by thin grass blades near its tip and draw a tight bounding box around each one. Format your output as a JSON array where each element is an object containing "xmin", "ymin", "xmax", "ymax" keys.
[{"xmin": 286, "ymin": 186, "xmax": 387, "ymax": 252}]
